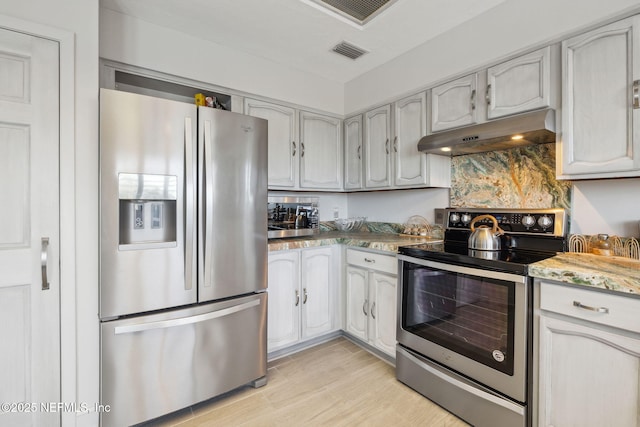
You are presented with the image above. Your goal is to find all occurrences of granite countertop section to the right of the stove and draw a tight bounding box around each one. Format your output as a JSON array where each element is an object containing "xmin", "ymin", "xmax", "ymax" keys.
[{"xmin": 529, "ymin": 252, "xmax": 640, "ymax": 296}]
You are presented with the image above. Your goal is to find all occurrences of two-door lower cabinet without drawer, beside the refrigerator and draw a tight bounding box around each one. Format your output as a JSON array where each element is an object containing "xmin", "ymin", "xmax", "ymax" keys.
[{"xmin": 267, "ymin": 246, "xmax": 339, "ymax": 352}]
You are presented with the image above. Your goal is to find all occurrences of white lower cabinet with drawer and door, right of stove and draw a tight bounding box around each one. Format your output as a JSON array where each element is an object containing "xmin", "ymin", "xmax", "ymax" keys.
[{"xmin": 534, "ymin": 280, "xmax": 640, "ymax": 427}]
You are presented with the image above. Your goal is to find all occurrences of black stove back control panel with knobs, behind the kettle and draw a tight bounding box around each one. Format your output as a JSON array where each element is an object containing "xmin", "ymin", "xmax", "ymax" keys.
[{"xmin": 445, "ymin": 208, "xmax": 568, "ymax": 236}]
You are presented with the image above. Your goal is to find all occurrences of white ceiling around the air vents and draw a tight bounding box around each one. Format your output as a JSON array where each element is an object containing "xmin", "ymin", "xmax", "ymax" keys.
[{"xmin": 100, "ymin": 0, "xmax": 506, "ymax": 83}]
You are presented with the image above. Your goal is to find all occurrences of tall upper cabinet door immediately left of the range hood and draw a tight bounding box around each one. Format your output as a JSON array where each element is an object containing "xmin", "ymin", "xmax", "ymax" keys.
[{"xmin": 393, "ymin": 92, "xmax": 427, "ymax": 187}]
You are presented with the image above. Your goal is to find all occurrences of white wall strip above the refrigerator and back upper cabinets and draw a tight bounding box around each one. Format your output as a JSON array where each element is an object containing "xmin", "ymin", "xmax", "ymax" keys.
[{"xmin": 100, "ymin": 9, "xmax": 344, "ymax": 114}]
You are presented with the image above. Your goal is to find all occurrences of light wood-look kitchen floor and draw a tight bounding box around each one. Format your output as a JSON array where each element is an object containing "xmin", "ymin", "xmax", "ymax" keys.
[{"xmin": 148, "ymin": 337, "xmax": 467, "ymax": 427}]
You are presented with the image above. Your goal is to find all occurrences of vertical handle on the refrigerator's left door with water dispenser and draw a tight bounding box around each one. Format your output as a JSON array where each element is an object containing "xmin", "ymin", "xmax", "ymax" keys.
[{"xmin": 183, "ymin": 117, "xmax": 194, "ymax": 290}]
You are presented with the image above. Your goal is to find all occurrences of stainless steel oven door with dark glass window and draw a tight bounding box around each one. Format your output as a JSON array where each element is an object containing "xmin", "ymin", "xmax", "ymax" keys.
[{"xmin": 397, "ymin": 255, "xmax": 530, "ymax": 402}]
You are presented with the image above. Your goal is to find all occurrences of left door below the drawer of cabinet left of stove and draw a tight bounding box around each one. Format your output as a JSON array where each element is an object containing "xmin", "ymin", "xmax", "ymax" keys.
[{"xmin": 345, "ymin": 265, "xmax": 369, "ymax": 341}]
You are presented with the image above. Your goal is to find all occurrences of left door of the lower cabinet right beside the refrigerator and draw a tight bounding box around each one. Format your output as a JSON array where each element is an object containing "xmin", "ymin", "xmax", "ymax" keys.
[{"xmin": 267, "ymin": 251, "xmax": 301, "ymax": 352}]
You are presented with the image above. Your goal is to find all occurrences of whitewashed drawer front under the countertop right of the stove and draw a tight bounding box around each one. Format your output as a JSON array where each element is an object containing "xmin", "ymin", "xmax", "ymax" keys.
[{"xmin": 540, "ymin": 282, "xmax": 640, "ymax": 333}]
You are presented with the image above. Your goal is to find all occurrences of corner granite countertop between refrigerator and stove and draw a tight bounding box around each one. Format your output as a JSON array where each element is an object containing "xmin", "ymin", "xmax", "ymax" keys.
[{"xmin": 269, "ymin": 231, "xmax": 442, "ymax": 253}]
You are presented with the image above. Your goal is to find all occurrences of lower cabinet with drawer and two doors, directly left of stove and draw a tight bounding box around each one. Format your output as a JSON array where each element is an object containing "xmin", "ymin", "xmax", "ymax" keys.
[{"xmin": 345, "ymin": 249, "xmax": 398, "ymax": 357}]
